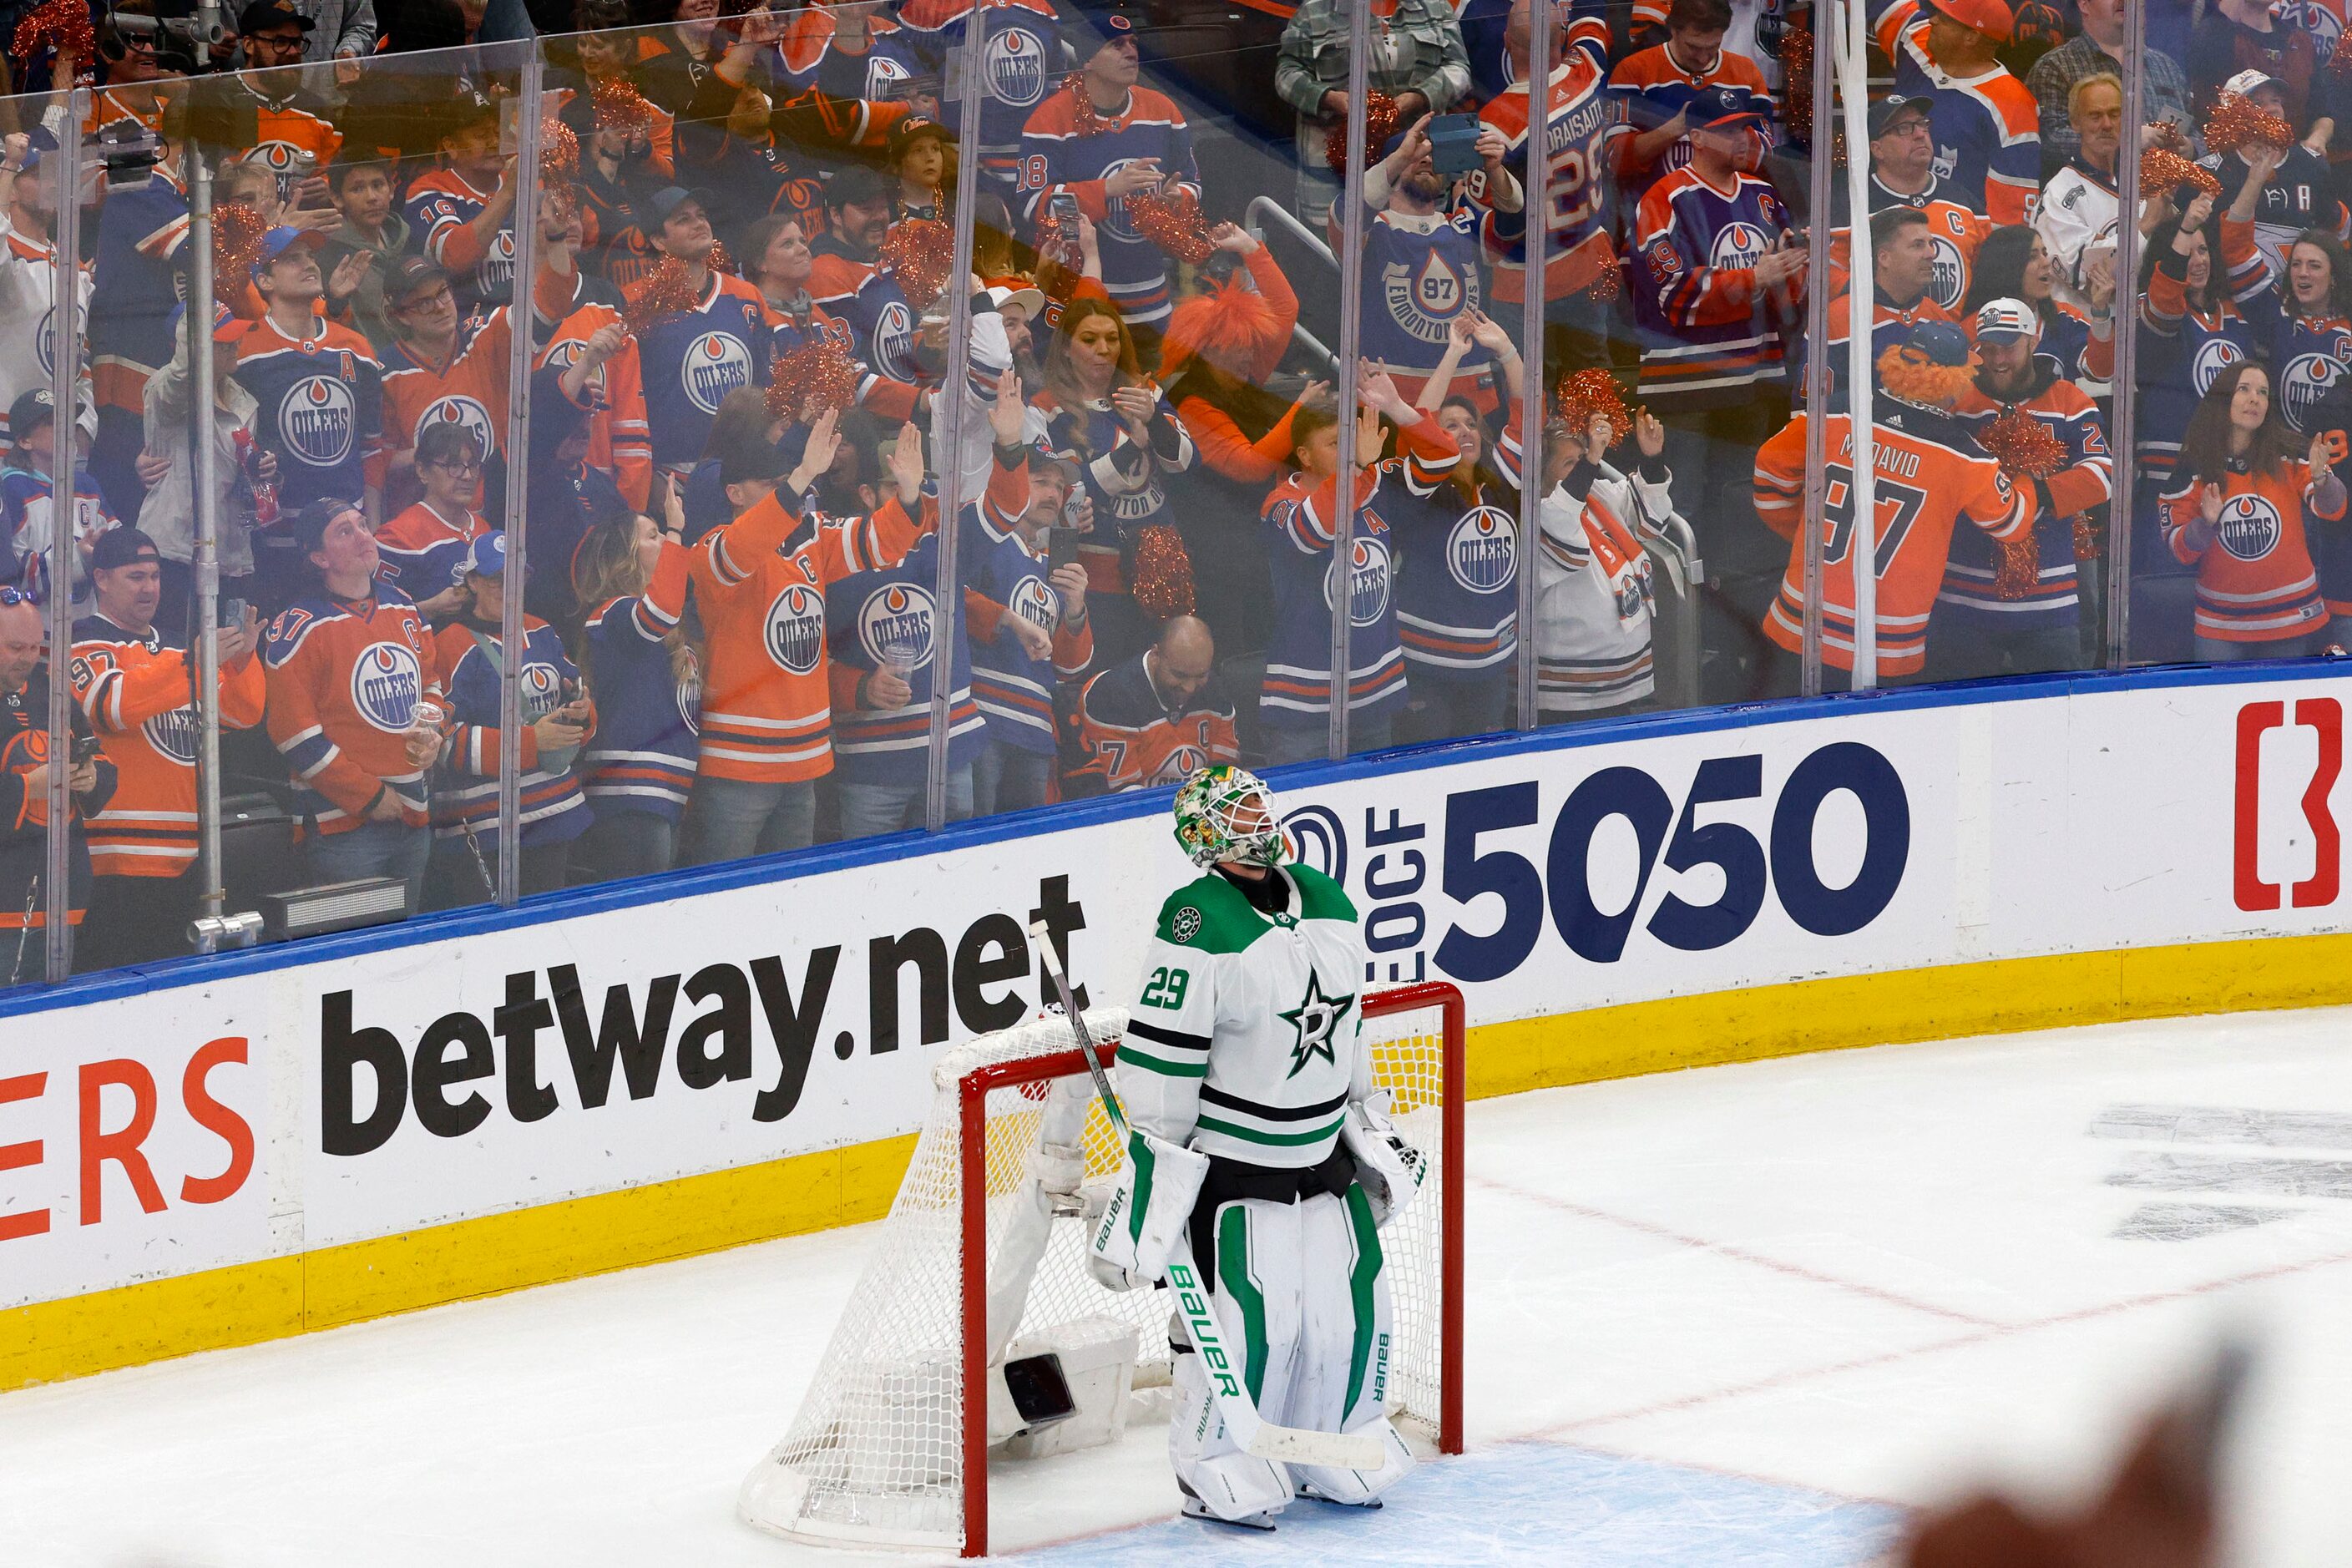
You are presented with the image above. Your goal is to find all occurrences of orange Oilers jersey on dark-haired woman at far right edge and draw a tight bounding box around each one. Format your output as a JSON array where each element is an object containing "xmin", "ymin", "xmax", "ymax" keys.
[{"xmin": 2162, "ymin": 458, "xmax": 2343, "ymax": 642}]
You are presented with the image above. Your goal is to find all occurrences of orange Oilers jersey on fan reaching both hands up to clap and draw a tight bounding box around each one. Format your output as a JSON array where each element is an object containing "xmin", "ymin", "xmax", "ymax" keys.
[{"xmin": 691, "ymin": 489, "xmax": 936, "ymax": 783}]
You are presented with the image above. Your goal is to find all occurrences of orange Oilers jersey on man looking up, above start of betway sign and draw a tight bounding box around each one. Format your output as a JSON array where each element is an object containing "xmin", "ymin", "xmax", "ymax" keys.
[{"xmin": 261, "ymin": 585, "xmax": 447, "ymax": 835}]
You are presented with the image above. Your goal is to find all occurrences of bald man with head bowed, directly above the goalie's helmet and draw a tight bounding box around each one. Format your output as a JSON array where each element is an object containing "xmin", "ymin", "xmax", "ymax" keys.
[{"xmin": 1070, "ymin": 616, "xmax": 1242, "ymax": 795}]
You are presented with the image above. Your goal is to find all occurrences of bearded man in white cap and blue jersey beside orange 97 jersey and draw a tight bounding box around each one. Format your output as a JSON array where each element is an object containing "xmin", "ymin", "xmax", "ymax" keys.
[{"xmin": 1926, "ymin": 299, "xmax": 2114, "ymax": 682}]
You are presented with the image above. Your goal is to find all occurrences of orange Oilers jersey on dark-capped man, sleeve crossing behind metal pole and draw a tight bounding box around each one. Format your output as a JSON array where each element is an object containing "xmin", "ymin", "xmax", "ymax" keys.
[{"xmin": 73, "ymin": 616, "xmax": 264, "ymax": 877}]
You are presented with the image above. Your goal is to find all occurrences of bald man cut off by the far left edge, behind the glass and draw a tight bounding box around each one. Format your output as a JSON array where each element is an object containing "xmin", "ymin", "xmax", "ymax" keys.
[{"xmin": 0, "ymin": 588, "xmax": 115, "ymax": 985}]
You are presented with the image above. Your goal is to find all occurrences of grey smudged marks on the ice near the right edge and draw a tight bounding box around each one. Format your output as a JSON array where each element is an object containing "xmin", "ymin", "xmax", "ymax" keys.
[{"xmin": 2088, "ymin": 1105, "xmax": 2352, "ymax": 1242}]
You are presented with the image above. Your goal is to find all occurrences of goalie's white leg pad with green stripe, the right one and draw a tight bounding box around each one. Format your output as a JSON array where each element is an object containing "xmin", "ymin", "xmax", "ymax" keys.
[{"xmin": 1266, "ymin": 1185, "xmax": 1414, "ymax": 1505}]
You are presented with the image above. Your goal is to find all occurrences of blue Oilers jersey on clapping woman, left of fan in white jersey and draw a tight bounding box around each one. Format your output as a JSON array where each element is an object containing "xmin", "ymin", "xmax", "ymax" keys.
[{"xmin": 1388, "ymin": 482, "xmax": 1520, "ymax": 684}]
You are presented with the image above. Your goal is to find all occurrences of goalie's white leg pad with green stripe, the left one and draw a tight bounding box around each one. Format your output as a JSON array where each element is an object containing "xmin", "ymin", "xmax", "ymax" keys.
[{"xmin": 1169, "ymin": 1199, "xmax": 1303, "ymax": 1519}]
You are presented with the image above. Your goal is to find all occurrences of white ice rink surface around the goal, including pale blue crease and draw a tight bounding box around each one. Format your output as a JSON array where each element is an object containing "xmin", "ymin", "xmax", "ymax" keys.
[{"xmin": 0, "ymin": 1011, "xmax": 2352, "ymax": 1568}]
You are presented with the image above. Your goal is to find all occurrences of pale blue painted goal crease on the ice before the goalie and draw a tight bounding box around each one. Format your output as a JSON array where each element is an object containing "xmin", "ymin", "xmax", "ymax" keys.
[{"xmin": 1002, "ymin": 1441, "xmax": 1903, "ymax": 1568}]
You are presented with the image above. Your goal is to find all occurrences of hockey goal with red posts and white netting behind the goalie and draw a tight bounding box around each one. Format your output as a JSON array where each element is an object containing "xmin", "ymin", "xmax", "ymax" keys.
[{"xmin": 739, "ymin": 983, "xmax": 1465, "ymax": 1556}]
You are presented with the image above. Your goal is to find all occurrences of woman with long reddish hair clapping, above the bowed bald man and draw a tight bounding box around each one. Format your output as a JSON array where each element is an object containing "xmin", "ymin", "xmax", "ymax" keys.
[{"xmin": 1034, "ymin": 296, "xmax": 1192, "ymax": 665}]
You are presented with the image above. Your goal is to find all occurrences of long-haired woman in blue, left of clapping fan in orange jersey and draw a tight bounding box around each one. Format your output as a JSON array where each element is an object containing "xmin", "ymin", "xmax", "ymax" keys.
[{"xmin": 572, "ymin": 489, "xmax": 703, "ymax": 879}]
